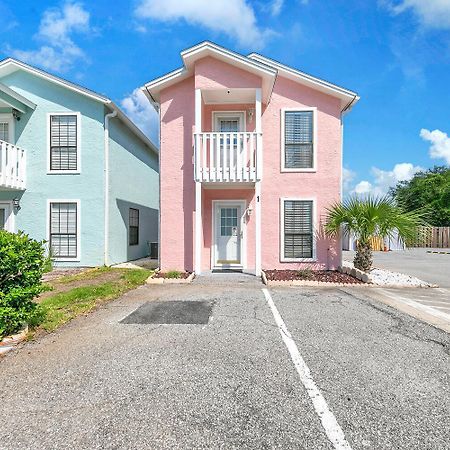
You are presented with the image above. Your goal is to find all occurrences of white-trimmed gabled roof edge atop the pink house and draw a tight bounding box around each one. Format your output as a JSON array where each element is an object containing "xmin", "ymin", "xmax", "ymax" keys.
[{"xmin": 141, "ymin": 41, "xmax": 359, "ymax": 111}]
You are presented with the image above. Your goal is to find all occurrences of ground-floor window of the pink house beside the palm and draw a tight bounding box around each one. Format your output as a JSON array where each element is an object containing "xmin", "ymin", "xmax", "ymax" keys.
[{"xmin": 282, "ymin": 200, "xmax": 314, "ymax": 260}]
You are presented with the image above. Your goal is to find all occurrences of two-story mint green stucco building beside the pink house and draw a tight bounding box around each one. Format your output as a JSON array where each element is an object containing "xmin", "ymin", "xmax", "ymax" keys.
[{"xmin": 0, "ymin": 58, "xmax": 159, "ymax": 266}]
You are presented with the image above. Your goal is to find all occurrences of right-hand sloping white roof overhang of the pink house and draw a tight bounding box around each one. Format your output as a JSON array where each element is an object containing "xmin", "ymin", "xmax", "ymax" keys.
[{"xmin": 248, "ymin": 53, "xmax": 359, "ymax": 112}]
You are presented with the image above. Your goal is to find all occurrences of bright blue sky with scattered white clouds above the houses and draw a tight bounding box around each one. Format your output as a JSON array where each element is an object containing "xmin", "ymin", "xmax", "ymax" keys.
[{"xmin": 0, "ymin": 0, "xmax": 450, "ymax": 193}]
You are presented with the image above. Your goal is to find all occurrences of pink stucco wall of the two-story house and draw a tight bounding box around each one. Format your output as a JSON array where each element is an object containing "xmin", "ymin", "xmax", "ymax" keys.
[{"xmin": 160, "ymin": 53, "xmax": 341, "ymax": 270}]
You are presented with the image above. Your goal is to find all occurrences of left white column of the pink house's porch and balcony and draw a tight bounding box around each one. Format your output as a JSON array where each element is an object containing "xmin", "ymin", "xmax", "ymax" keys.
[{"xmin": 194, "ymin": 89, "xmax": 202, "ymax": 275}]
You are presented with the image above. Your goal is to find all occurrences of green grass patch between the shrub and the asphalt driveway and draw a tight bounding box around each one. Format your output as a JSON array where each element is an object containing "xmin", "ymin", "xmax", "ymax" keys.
[{"xmin": 40, "ymin": 267, "xmax": 152, "ymax": 332}]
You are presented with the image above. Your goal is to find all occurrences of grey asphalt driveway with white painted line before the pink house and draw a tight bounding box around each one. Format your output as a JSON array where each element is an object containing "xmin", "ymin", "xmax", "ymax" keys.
[{"xmin": 0, "ymin": 275, "xmax": 450, "ymax": 450}]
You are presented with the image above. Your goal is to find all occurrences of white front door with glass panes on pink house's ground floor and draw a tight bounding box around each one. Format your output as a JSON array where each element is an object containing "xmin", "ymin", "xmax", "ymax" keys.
[{"xmin": 214, "ymin": 202, "xmax": 243, "ymax": 267}]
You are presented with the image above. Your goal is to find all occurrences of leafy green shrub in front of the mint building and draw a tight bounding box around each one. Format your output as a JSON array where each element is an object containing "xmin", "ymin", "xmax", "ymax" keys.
[{"xmin": 0, "ymin": 230, "xmax": 48, "ymax": 337}]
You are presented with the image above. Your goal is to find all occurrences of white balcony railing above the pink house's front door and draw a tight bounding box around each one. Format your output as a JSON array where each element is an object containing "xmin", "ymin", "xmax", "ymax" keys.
[{"xmin": 194, "ymin": 132, "xmax": 262, "ymax": 182}]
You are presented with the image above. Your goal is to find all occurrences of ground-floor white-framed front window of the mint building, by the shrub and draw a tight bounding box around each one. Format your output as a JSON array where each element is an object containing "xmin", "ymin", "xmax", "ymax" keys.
[{"xmin": 50, "ymin": 202, "xmax": 78, "ymax": 258}]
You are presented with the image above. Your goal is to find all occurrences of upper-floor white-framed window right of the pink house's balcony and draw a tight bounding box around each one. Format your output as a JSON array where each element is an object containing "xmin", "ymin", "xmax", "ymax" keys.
[{"xmin": 283, "ymin": 110, "xmax": 314, "ymax": 170}]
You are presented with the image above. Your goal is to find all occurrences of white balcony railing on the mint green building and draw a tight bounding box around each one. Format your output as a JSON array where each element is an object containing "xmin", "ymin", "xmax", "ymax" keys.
[{"xmin": 0, "ymin": 141, "xmax": 26, "ymax": 190}]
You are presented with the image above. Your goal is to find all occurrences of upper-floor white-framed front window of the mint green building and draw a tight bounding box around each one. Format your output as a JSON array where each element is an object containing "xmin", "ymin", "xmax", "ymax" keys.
[{"xmin": 50, "ymin": 114, "xmax": 79, "ymax": 172}]
